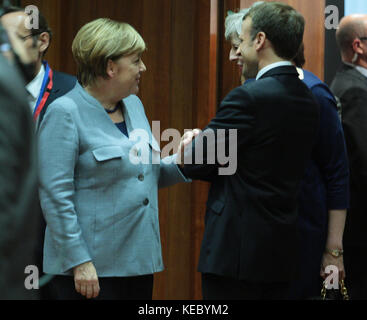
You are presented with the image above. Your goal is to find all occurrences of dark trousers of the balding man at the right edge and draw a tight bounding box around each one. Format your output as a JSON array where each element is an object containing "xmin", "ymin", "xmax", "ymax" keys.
[{"xmin": 344, "ymin": 245, "xmax": 367, "ymax": 300}]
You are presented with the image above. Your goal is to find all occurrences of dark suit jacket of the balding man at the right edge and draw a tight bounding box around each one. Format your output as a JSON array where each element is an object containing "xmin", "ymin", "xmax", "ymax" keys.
[{"xmin": 331, "ymin": 64, "xmax": 367, "ymax": 247}]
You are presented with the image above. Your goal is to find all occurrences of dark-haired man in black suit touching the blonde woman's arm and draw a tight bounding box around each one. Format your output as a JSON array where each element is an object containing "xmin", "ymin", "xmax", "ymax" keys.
[{"xmin": 183, "ymin": 2, "xmax": 319, "ymax": 299}]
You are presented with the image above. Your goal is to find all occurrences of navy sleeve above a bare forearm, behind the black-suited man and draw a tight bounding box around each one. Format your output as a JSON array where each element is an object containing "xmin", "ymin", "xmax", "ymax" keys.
[{"xmin": 312, "ymin": 85, "xmax": 349, "ymax": 210}]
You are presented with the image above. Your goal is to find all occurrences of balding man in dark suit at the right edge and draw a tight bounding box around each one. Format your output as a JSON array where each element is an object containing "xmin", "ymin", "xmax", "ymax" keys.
[{"xmin": 331, "ymin": 15, "xmax": 367, "ymax": 299}]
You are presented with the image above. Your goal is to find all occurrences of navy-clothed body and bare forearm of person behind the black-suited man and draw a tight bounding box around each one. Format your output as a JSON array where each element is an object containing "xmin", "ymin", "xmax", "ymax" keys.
[{"xmin": 290, "ymin": 44, "xmax": 349, "ymax": 299}]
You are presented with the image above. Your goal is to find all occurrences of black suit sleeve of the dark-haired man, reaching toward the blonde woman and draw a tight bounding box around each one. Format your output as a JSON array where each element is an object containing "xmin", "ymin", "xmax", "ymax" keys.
[{"xmin": 183, "ymin": 87, "xmax": 255, "ymax": 181}]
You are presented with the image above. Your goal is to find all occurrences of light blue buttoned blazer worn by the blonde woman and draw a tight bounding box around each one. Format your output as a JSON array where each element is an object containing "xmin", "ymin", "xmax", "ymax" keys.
[{"xmin": 39, "ymin": 84, "xmax": 190, "ymax": 277}]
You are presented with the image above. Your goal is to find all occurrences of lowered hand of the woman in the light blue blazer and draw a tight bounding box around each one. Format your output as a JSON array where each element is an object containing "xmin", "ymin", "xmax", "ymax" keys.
[{"xmin": 74, "ymin": 262, "xmax": 100, "ymax": 299}]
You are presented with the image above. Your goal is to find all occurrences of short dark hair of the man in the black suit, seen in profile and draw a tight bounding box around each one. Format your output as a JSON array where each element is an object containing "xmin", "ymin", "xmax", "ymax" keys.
[{"xmin": 244, "ymin": 2, "xmax": 305, "ymax": 60}]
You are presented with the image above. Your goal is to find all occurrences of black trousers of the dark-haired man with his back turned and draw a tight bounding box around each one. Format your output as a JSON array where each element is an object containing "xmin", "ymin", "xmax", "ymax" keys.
[{"xmin": 202, "ymin": 274, "xmax": 289, "ymax": 300}]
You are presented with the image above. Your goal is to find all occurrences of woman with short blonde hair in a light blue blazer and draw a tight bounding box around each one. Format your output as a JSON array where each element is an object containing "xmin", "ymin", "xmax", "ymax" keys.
[{"xmin": 39, "ymin": 19, "xmax": 196, "ymax": 300}]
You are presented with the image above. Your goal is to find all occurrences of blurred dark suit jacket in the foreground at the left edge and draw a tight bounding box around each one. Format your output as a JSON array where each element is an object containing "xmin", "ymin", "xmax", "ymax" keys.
[{"xmin": 0, "ymin": 55, "xmax": 38, "ymax": 299}]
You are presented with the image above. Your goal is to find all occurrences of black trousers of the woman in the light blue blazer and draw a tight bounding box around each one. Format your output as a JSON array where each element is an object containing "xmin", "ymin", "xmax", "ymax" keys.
[{"xmin": 50, "ymin": 275, "xmax": 154, "ymax": 300}]
